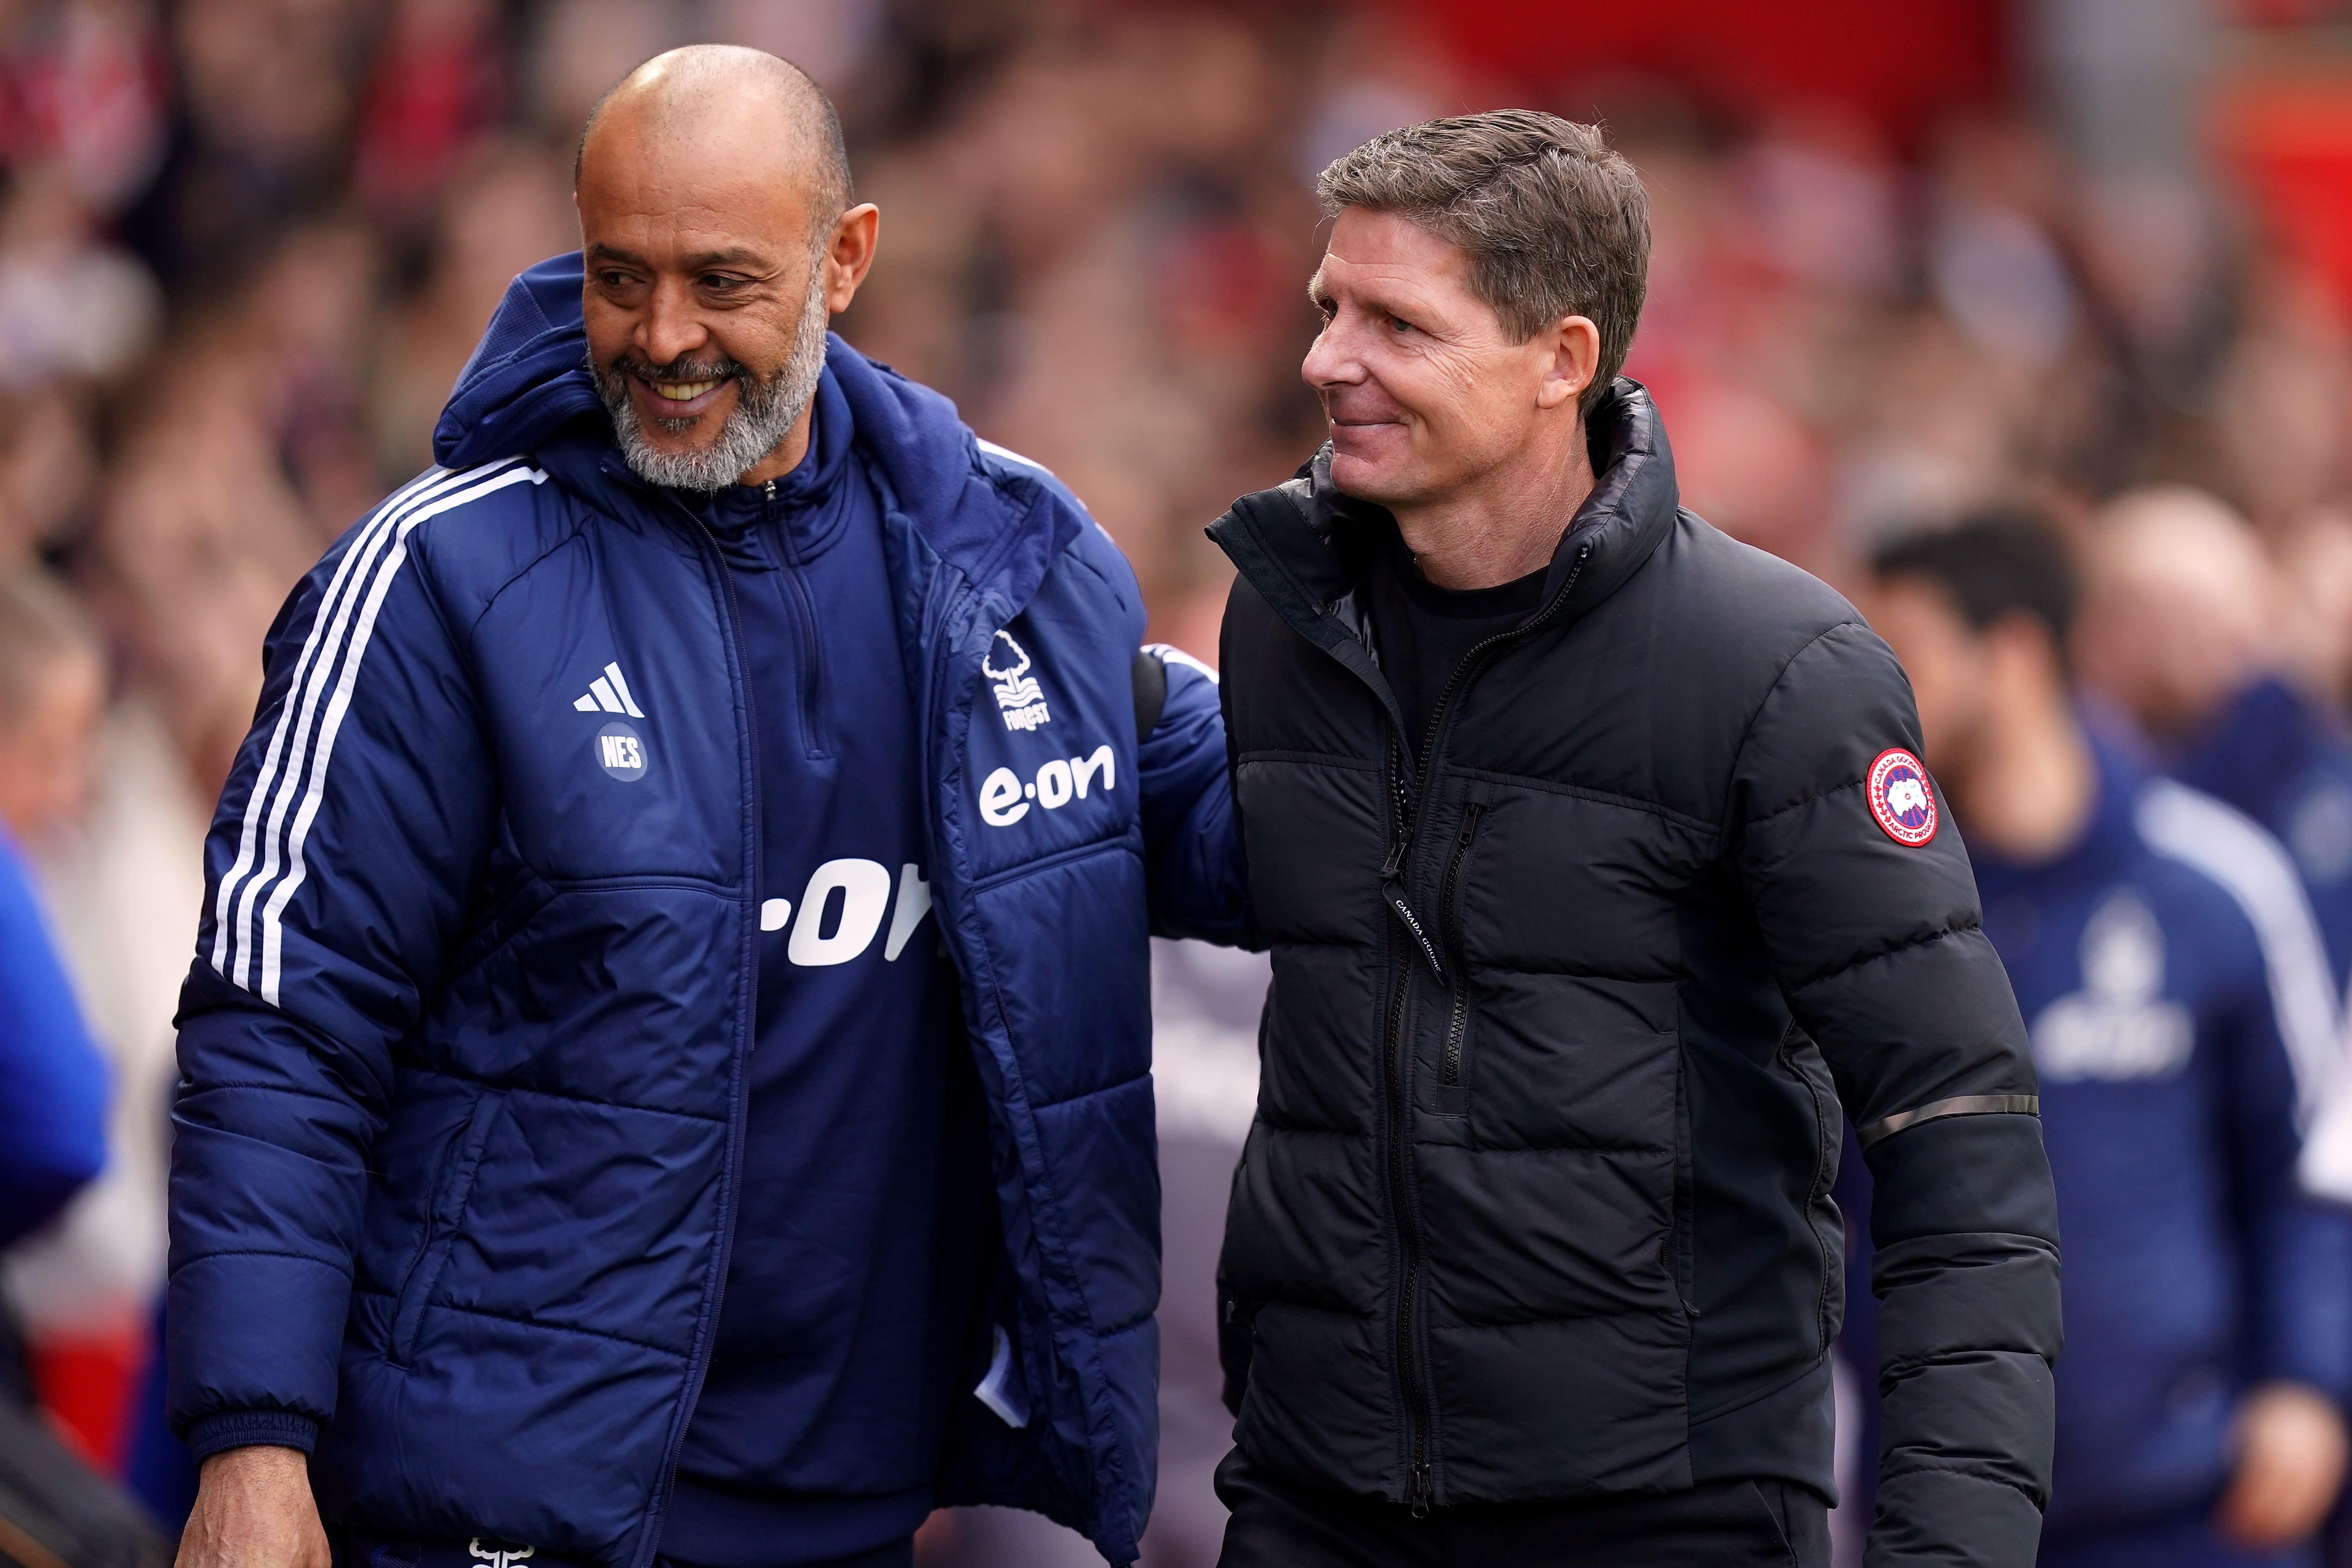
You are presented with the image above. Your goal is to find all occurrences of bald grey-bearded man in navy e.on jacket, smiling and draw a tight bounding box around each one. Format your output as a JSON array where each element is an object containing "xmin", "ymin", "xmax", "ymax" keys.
[{"xmin": 170, "ymin": 47, "xmax": 1244, "ymax": 1568}]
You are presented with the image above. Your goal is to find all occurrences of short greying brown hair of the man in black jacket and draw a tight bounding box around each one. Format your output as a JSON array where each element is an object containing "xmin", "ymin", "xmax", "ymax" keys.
[{"xmin": 1315, "ymin": 108, "xmax": 1649, "ymax": 414}]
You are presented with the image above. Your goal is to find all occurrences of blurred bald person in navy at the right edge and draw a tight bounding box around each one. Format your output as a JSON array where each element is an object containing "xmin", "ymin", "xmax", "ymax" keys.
[{"xmin": 2077, "ymin": 487, "xmax": 2352, "ymax": 1006}]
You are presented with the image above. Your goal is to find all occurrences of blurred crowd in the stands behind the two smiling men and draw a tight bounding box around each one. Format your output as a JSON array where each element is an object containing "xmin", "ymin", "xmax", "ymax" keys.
[{"xmin": 0, "ymin": 0, "xmax": 2352, "ymax": 1568}]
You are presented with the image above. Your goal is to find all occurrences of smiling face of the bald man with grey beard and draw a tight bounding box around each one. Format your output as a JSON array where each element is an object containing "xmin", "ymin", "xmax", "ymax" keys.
[{"xmin": 574, "ymin": 61, "xmax": 875, "ymax": 489}]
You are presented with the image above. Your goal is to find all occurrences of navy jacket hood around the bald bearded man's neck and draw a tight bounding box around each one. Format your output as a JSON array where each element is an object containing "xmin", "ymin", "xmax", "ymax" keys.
[{"xmin": 433, "ymin": 252, "xmax": 1085, "ymax": 602}]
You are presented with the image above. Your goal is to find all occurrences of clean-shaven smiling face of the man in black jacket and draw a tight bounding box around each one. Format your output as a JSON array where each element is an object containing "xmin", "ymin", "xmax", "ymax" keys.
[{"xmin": 1298, "ymin": 207, "xmax": 1600, "ymax": 508}]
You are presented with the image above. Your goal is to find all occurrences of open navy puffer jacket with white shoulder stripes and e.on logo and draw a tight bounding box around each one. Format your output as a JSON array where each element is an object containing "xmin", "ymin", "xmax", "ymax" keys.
[{"xmin": 170, "ymin": 256, "xmax": 1242, "ymax": 1568}]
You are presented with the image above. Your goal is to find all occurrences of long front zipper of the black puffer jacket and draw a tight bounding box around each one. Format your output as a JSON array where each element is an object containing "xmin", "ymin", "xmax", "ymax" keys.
[{"xmin": 1381, "ymin": 541, "xmax": 1592, "ymax": 1519}]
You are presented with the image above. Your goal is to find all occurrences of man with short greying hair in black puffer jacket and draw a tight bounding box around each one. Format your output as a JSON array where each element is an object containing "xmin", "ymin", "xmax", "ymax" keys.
[{"xmin": 1211, "ymin": 111, "xmax": 2058, "ymax": 1568}]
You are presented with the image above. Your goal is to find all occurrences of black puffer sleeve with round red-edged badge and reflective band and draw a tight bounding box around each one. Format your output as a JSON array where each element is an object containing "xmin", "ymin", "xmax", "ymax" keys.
[{"xmin": 1731, "ymin": 623, "xmax": 2060, "ymax": 1568}]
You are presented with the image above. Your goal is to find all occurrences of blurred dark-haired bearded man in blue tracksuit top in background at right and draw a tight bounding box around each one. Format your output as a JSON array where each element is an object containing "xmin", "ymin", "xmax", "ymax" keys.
[{"xmin": 1858, "ymin": 517, "xmax": 2352, "ymax": 1568}]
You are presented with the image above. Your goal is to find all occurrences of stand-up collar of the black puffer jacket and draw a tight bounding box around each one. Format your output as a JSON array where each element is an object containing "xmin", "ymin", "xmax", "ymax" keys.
[{"xmin": 1209, "ymin": 376, "xmax": 1682, "ymax": 625}]
